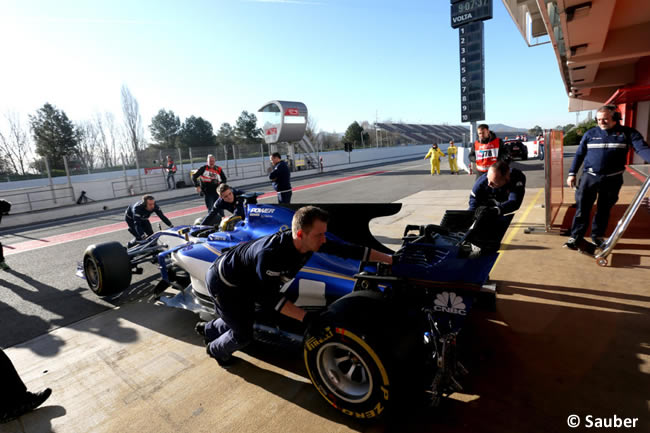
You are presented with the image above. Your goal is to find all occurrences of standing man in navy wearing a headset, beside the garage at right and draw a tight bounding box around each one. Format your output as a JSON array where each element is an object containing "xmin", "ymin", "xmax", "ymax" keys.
[{"xmin": 564, "ymin": 105, "xmax": 650, "ymax": 250}]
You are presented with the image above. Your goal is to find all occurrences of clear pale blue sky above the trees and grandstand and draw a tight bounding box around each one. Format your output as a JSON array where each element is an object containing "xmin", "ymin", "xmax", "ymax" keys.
[{"xmin": 0, "ymin": 0, "xmax": 584, "ymax": 132}]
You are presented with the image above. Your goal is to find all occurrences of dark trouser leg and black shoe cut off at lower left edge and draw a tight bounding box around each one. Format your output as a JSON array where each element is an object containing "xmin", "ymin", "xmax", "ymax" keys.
[{"xmin": 0, "ymin": 349, "xmax": 52, "ymax": 424}]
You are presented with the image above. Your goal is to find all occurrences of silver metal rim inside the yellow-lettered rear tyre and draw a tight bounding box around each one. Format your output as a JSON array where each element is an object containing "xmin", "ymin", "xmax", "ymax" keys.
[{"xmin": 316, "ymin": 342, "xmax": 373, "ymax": 403}]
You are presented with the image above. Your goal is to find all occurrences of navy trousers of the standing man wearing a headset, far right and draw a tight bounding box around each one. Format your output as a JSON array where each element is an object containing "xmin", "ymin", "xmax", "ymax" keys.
[{"xmin": 571, "ymin": 173, "xmax": 623, "ymax": 239}]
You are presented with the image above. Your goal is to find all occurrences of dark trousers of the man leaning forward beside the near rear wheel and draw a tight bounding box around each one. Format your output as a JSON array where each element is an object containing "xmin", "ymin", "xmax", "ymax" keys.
[{"xmin": 205, "ymin": 260, "xmax": 255, "ymax": 358}]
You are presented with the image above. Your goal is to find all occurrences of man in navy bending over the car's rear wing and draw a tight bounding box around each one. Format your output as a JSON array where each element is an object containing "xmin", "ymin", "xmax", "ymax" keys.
[{"xmin": 469, "ymin": 161, "xmax": 526, "ymax": 219}]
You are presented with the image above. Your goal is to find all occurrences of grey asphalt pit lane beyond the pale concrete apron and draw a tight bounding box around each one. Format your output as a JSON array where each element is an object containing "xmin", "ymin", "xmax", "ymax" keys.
[{"xmin": 0, "ymin": 160, "xmax": 544, "ymax": 350}]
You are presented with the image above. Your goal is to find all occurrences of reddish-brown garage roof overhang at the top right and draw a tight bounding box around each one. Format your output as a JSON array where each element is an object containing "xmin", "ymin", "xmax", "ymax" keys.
[{"xmin": 503, "ymin": 0, "xmax": 650, "ymax": 111}]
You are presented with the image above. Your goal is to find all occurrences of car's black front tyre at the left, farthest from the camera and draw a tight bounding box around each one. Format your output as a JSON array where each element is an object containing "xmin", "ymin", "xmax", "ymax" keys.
[{"xmin": 83, "ymin": 242, "xmax": 131, "ymax": 296}]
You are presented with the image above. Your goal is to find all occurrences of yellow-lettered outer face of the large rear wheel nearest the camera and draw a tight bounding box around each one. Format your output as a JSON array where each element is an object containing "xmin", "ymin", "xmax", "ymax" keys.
[{"xmin": 304, "ymin": 325, "xmax": 391, "ymax": 418}]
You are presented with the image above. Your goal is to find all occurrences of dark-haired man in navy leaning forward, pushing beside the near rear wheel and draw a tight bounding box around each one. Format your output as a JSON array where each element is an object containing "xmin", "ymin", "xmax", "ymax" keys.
[{"xmin": 195, "ymin": 206, "xmax": 393, "ymax": 366}]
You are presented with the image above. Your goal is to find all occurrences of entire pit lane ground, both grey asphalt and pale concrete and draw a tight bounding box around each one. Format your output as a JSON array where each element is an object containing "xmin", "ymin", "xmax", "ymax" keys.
[{"xmin": 5, "ymin": 156, "xmax": 650, "ymax": 432}]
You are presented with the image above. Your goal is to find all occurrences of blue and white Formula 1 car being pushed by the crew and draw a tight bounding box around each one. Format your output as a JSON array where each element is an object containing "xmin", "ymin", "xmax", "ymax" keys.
[{"xmin": 77, "ymin": 203, "xmax": 512, "ymax": 418}]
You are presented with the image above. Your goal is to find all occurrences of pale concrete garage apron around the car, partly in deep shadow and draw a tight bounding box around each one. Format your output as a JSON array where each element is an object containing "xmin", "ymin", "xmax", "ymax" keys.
[{"xmin": 0, "ymin": 187, "xmax": 650, "ymax": 433}]
